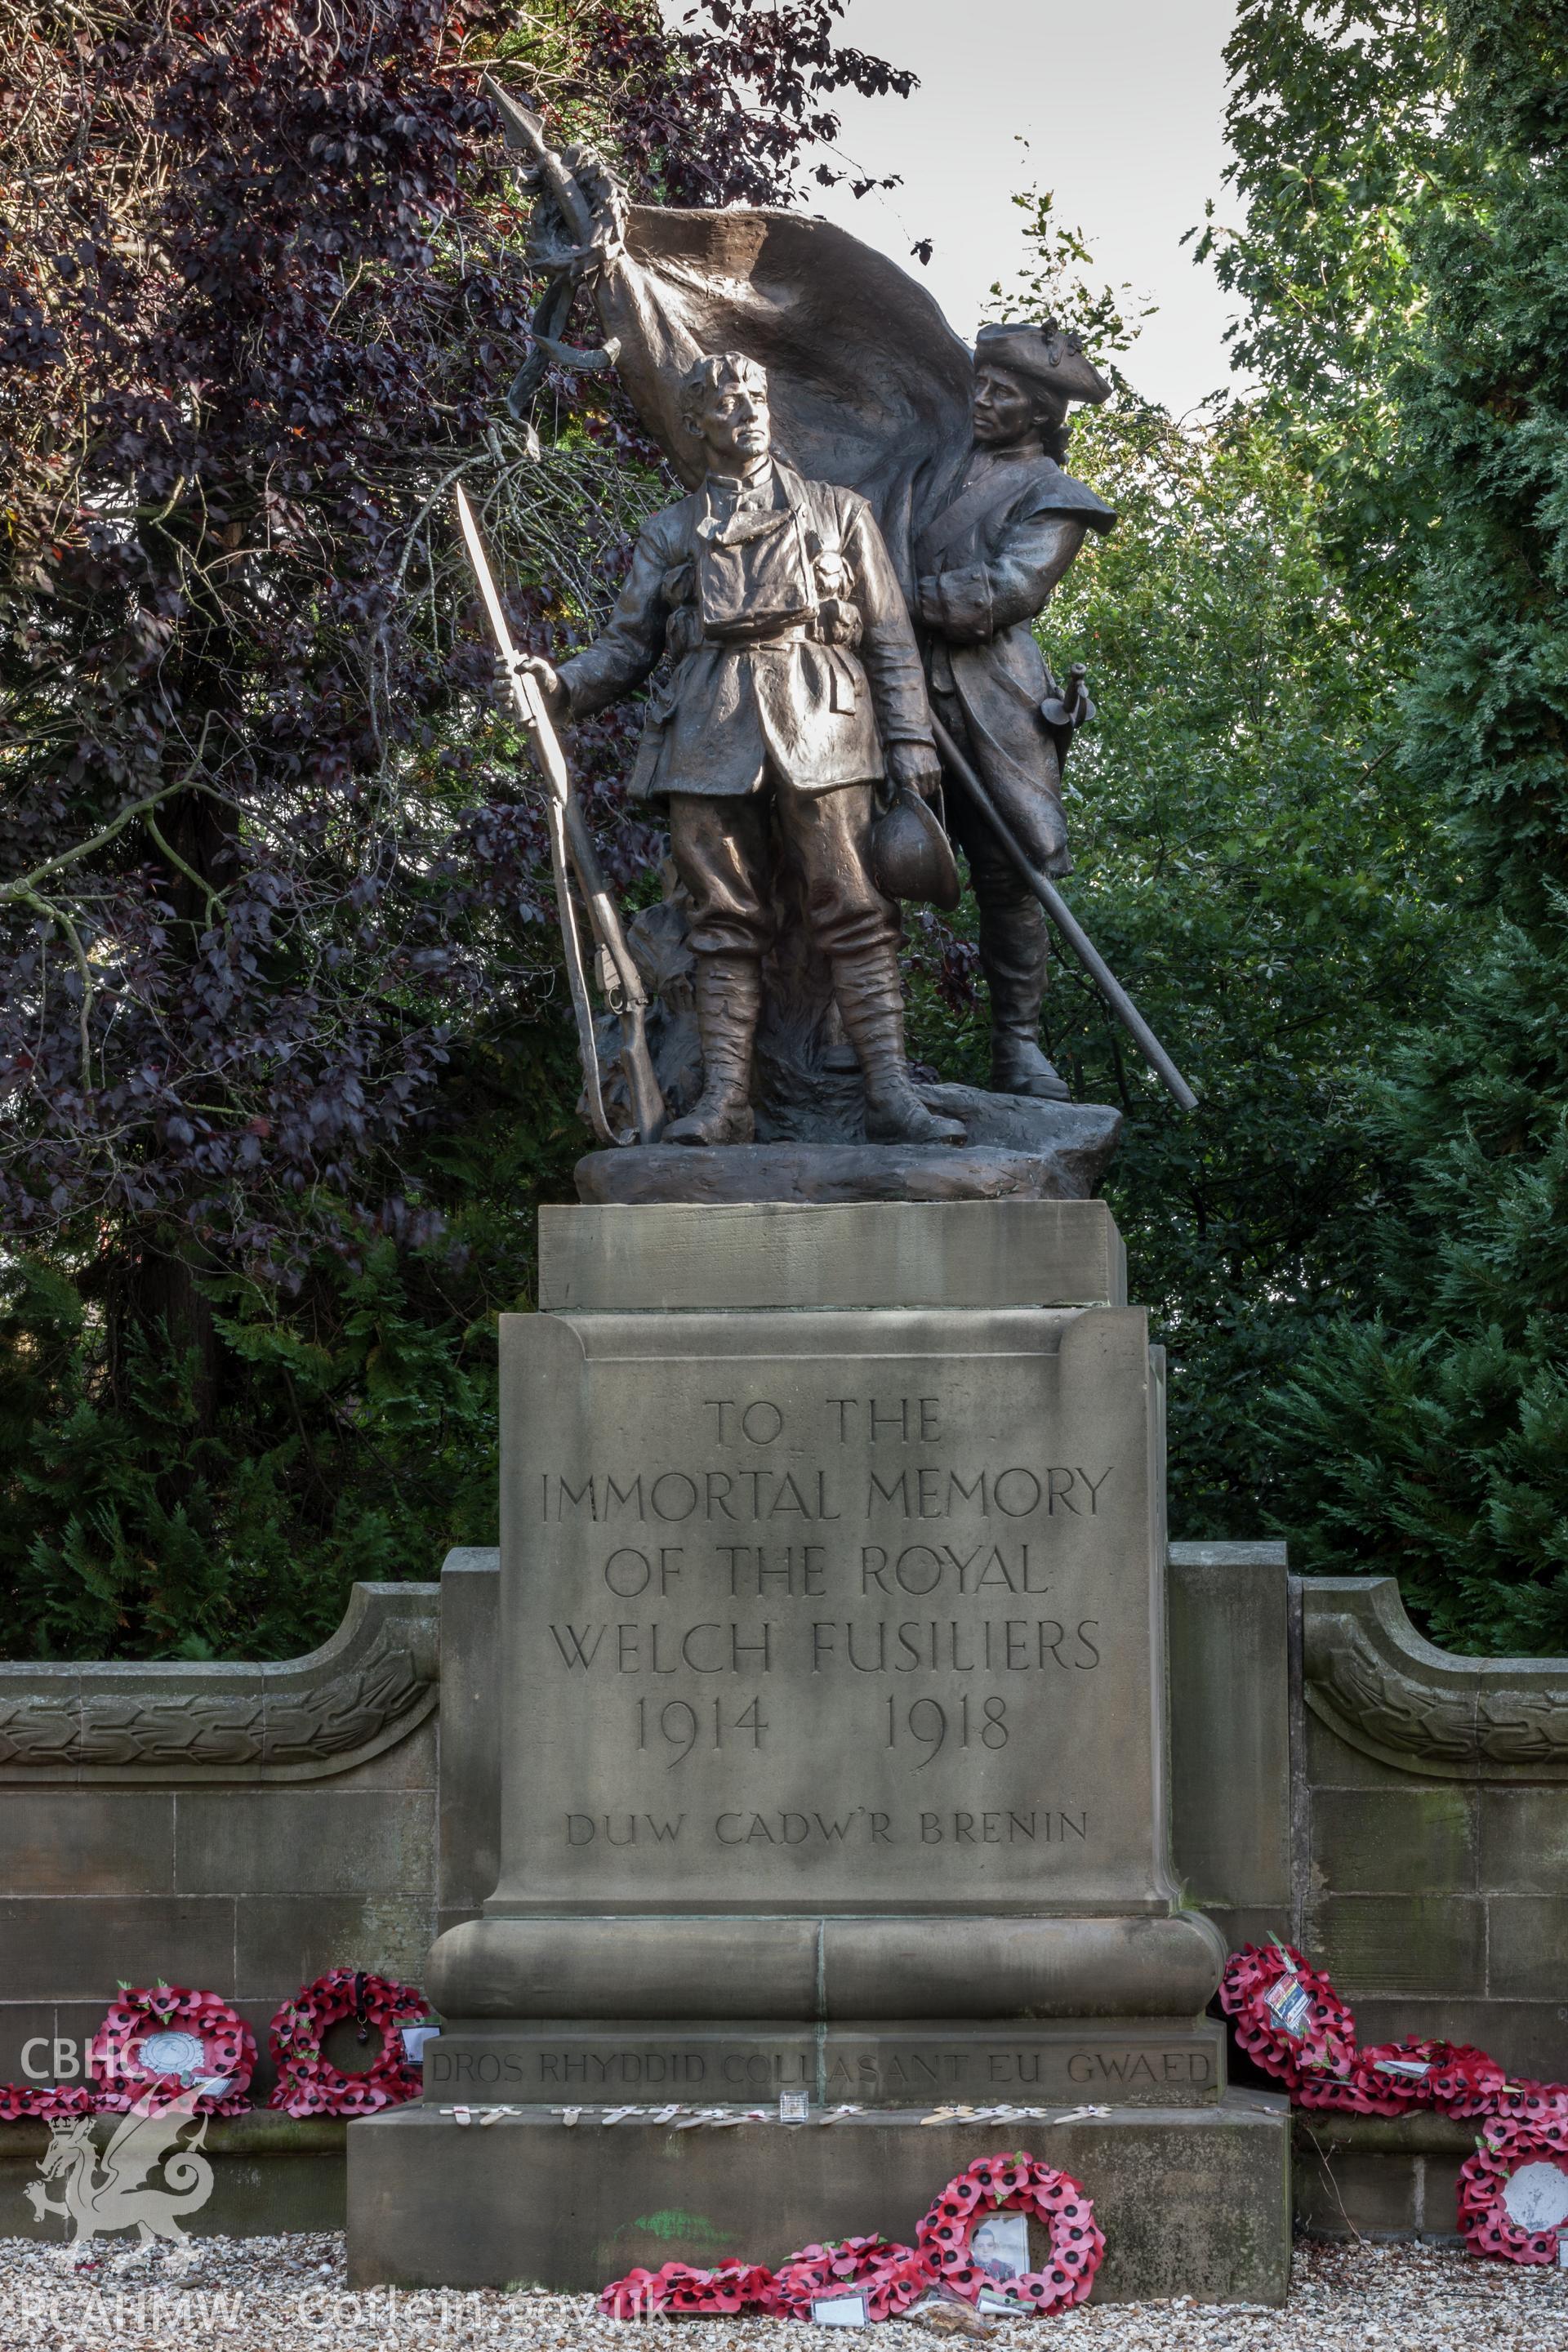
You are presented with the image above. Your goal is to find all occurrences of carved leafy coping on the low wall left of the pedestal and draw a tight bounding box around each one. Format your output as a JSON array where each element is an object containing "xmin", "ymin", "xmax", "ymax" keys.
[{"xmin": 0, "ymin": 1585, "xmax": 437, "ymax": 1780}]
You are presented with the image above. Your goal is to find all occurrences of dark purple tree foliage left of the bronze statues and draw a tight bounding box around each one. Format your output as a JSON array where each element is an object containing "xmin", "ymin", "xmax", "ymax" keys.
[{"xmin": 0, "ymin": 0, "xmax": 910, "ymax": 1284}]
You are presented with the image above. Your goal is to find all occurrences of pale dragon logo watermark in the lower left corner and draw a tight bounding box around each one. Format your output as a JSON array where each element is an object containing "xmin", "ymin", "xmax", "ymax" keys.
[{"xmin": 21, "ymin": 2084, "xmax": 212, "ymax": 2246}]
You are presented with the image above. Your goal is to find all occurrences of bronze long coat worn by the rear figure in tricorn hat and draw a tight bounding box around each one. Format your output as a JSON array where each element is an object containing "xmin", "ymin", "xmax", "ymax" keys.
[{"xmin": 915, "ymin": 452, "xmax": 1116, "ymax": 872}]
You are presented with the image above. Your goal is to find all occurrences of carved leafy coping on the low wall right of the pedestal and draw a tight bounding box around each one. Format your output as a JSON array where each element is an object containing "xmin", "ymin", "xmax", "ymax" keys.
[{"xmin": 1303, "ymin": 1576, "xmax": 1568, "ymax": 1780}]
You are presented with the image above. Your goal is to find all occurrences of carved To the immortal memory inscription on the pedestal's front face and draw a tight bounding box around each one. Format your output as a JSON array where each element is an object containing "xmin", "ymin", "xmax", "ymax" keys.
[{"xmin": 524, "ymin": 1385, "xmax": 1119, "ymax": 1863}]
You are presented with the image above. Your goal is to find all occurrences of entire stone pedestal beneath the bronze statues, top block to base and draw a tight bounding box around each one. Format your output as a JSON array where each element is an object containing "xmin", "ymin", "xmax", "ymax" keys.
[{"xmin": 350, "ymin": 1204, "xmax": 1286, "ymax": 2298}]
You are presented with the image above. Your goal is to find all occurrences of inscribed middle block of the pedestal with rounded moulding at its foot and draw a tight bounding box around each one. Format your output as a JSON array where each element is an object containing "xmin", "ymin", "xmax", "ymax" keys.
[{"xmin": 430, "ymin": 1241, "xmax": 1223, "ymax": 2020}]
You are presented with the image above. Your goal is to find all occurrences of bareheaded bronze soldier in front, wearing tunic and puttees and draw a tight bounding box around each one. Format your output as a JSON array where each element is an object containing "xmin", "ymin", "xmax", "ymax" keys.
[{"xmin": 529, "ymin": 355, "xmax": 964, "ymax": 1143}]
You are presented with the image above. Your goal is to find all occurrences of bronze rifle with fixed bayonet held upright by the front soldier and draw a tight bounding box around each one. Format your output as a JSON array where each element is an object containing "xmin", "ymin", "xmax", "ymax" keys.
[{"xmin": 458, "ymin": 482, "xmax": 666, "ymax": 1143}]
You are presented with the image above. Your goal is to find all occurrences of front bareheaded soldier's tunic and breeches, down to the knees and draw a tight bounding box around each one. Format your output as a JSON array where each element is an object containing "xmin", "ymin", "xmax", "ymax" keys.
[{"xmin": 559, "ymin": 461, "xmax": 931, "ymax": 955}]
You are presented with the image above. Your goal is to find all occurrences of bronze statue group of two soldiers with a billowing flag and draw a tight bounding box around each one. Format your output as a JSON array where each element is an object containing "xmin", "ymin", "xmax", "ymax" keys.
[{"xmin": 472, "ymin": 87, "xmax": 1192, "ymax": 1146}]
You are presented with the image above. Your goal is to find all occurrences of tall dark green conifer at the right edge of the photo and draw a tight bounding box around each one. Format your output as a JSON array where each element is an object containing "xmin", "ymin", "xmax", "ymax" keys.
[{"xmin": 1265, "ymin": 0, "xmax": 1568, "ymax": 1651}]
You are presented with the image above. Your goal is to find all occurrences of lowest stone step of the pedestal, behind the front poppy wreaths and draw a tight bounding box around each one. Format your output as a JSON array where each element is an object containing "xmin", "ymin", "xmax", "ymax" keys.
[{"xmin": 348, "ymin": 2091, "xmax": 1290, "ymax": 2295}]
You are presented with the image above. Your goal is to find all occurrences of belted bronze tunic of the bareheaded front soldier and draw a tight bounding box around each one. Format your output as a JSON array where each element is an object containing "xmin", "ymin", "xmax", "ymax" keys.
[{"xmin": 559, "ymin": 461, "xmax": 931, "ymax": 800}]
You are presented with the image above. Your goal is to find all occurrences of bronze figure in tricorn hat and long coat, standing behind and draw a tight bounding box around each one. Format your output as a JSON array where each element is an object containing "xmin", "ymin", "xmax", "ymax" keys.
[{"xmin": 915, "ymin": 323, "xmax": 1116, "ymax": 1098}]
